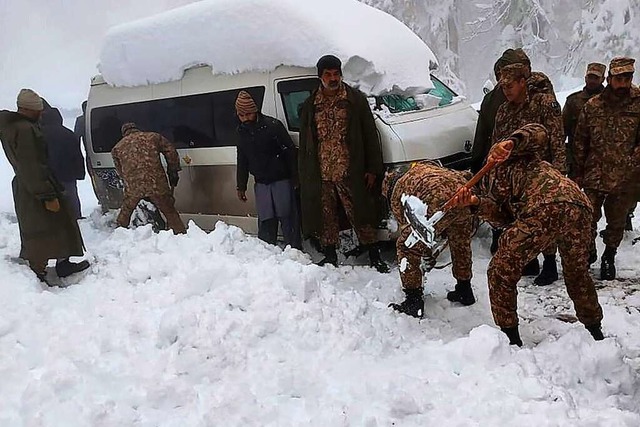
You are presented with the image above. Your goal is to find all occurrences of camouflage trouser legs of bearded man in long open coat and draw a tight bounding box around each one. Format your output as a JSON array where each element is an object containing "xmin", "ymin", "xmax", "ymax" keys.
[{"xmin": 320, "ymin": 181, "xmax": 378, "ymax": 247}]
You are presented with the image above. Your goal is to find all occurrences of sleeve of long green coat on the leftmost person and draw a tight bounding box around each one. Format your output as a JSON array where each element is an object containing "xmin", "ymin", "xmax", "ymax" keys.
[{"xmin": 15, "ymin": 128, "xmax": 58, "ymax": 201}]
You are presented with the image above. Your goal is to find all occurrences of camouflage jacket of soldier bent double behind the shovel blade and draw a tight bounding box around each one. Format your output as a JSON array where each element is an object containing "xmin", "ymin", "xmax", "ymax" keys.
[{"xmin": 383, "ymin": 162, "xmax": 471, "ymax": 234}]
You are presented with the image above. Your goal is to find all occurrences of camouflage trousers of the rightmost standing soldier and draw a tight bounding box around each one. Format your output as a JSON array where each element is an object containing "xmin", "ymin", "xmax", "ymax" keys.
[{"xmin": 584, "ymin": 189, "xmax": 636, "ymax": 249}]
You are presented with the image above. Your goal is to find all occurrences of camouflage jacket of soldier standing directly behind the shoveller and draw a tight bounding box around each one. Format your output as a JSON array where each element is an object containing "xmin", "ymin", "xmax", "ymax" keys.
[{"xmin": 492, "ymin": 92, "xmax": 567, "ymax": 173}]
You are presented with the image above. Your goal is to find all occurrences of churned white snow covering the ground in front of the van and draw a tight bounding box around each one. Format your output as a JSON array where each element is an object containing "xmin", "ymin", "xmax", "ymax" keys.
[{"xmin": 0, "ymin": 206, "xmax": 640, "ymax": 427}]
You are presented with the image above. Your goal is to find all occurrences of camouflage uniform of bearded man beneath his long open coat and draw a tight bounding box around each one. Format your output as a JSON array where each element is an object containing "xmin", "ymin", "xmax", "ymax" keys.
[{"xmin": 313, "ymin": 85, "xmax": 377, "ymax": 246}]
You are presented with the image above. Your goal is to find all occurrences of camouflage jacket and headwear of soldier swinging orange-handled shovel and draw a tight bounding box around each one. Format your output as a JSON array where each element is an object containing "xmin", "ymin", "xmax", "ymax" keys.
[{"xmin": 478, "ymin": 124, "xmax": 591, "ymax": 227}]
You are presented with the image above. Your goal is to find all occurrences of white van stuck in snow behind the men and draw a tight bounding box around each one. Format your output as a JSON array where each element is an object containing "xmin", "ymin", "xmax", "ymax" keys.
[{"xmin": 86, "ymin": 66, "xmax": 477, "ymax": 233}]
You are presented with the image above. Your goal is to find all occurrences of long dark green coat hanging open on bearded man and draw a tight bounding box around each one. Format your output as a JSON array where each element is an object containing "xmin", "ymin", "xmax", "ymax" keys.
[{"xmin": 298, "ymin": 85, "xmax": 384, "ymax": 237}]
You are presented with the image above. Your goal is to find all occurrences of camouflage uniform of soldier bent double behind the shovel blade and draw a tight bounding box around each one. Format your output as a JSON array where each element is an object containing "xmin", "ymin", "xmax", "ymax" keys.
[{"xmin": 382, "ymin": 162, "xmax": 473, "ymax": 289}]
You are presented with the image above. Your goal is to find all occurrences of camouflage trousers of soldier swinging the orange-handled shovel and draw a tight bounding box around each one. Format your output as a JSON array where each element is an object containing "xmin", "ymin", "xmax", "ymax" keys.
[{"xmin": 487, "ymin": 202, "xmax": 602, "ymax": 328}]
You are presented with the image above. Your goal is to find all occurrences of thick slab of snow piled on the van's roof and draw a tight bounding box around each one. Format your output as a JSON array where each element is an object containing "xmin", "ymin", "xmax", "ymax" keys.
[{"xmin": 98, "ymin": 0, "xmax": 437, "ymax": 95}]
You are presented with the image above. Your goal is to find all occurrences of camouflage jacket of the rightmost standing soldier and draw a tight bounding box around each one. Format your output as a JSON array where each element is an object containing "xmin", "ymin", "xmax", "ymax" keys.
[{"xmin": 574, "ymin": 87, "xmax": 640, "ymax": 192}]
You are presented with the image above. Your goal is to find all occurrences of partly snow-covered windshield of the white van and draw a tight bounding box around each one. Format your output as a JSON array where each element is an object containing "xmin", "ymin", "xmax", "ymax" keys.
[{"xmin": 375, "ymin": 75, "xmax": 457, "ymax": 113}]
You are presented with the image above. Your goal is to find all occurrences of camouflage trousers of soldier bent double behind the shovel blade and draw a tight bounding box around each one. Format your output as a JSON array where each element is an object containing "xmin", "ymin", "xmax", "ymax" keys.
[{"xmin": 396, "ymin": 216, "xmax": 473, "ymax": 289}]
